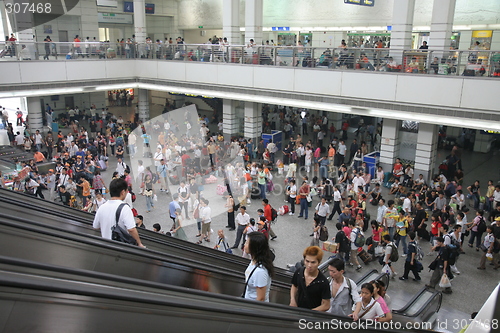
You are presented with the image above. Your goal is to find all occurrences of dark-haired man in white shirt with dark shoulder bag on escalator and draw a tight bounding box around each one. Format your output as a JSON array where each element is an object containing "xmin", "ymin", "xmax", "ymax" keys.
[{"xmin": 93, "ymin": 178, "xmax": 145, "ymax": 247}]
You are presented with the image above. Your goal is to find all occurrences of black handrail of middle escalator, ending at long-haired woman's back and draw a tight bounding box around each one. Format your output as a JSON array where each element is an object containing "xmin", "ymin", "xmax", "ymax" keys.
[{"xmin": 0, "ymin": 216, "xmax": 290, "ymax": 288}]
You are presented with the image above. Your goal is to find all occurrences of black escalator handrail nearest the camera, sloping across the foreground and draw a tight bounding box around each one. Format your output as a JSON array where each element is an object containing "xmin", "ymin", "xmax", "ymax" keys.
[{"xmin": 0, "ymin": 257, "xmax": 436, "ymax": 332}]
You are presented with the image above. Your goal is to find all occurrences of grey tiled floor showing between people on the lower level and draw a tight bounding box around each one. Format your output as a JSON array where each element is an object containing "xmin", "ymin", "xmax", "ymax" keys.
[{"xmin": 4, "ymin": 102, "xmax": 500, "ymax": 332}]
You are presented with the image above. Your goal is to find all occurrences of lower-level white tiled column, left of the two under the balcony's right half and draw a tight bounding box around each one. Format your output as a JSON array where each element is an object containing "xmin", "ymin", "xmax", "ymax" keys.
[{"xmin": 380, "ymin": 119, "xmax": 401, "ymax": 172}]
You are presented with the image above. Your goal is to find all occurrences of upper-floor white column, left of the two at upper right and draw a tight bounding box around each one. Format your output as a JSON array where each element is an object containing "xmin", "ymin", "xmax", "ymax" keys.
[{"xmin": 390, "ymin": 0, "xmax": 416, "ymax": 64}]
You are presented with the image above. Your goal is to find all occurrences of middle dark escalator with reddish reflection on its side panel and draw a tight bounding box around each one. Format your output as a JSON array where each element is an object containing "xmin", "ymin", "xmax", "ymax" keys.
[{"xmin": 0, "ymin": 212, "xmax": 290, "ymax": 304}]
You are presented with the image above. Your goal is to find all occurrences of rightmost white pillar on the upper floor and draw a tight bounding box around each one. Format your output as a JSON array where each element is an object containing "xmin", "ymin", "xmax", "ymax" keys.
[{"xmin": 429, "ymin": 0, "xmax": 456, "ymax": 57}]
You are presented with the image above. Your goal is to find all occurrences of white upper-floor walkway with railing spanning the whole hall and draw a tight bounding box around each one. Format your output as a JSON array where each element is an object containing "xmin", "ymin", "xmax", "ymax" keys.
[{"xmin": 0, "ymin": 43, "xmax": 500, "ymax": 130}]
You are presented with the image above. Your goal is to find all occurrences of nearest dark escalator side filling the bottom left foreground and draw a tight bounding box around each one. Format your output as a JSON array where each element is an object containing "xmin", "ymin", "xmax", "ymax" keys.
[{"xmin": 0, "ymin": 257, "xmax": 434, "ymax": 333}]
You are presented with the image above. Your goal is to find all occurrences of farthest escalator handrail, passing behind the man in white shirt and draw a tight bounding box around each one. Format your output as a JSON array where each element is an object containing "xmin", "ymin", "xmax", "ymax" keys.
[{"xmin": 0, "ymin": 189, "xmax": 292, "ymax": 281}]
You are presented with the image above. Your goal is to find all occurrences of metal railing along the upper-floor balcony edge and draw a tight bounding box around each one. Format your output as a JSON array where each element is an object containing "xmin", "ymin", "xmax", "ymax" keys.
[{"xmin": 0, "ymin": 41, "xmax": 500, "ymax": 77}]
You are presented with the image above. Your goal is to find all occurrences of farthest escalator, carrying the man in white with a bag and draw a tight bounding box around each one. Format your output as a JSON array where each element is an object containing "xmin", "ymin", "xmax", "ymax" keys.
[{"xmin": 0, "ymin": 189, "xmax": 292, "ymax": 284}]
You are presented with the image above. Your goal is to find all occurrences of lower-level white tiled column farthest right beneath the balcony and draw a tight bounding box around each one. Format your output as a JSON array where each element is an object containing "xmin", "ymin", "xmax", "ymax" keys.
[{"xmin": 414, "ymin": 120, "xmax": 439, "ymax": 180}]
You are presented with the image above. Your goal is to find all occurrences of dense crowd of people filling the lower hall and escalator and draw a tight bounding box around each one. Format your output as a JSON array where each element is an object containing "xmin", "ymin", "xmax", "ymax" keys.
[{"xmin": 1, "ymin": 100, "xmax": 500, "ymax": 321}]
